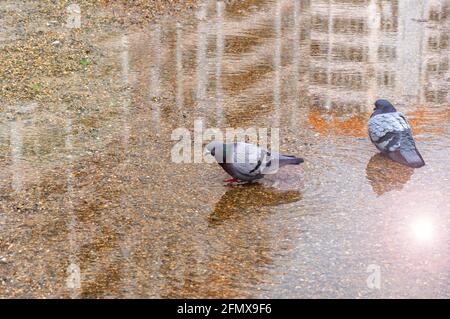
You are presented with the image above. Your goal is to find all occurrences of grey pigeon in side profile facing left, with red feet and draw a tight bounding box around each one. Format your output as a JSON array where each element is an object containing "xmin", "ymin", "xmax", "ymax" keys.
[{"xmin": 206, "ymin": 141, "xmax": 303, "ymax": 182}]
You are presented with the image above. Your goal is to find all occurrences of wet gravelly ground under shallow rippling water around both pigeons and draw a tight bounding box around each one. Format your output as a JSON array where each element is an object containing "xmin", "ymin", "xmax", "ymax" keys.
[{"xmin": 0, "ymin": 0, "xmax": 450, "ymax": 298}]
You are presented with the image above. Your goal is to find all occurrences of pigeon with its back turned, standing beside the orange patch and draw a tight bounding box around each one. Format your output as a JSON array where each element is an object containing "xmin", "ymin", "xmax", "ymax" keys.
[{"xmin": 369, "ymin": 100, "xmax": 425, "ymax": 168}]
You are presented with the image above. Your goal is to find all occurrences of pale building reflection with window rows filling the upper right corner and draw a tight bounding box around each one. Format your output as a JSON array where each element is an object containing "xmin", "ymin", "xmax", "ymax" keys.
[{"xmin": 310, "ymin": 0, "xmax": 448, "ymax": 111}]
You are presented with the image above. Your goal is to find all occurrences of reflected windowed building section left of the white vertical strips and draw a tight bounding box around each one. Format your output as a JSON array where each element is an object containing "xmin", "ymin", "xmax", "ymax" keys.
[{"xmin": 310, "ymin": 1, "xmax": 372, "ymax": 109}]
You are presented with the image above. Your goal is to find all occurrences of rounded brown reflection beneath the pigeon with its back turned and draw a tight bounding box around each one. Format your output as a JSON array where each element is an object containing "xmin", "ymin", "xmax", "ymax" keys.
[{"xmin": 366, "ymin": 153, "xmax": 414, "ymax": 196}]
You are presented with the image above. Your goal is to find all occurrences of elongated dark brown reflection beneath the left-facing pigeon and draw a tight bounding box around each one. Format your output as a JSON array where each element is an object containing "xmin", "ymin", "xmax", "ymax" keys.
[{"xmin": 209, "ymin": 183, "xmax": 302, "ymax": 226}]
